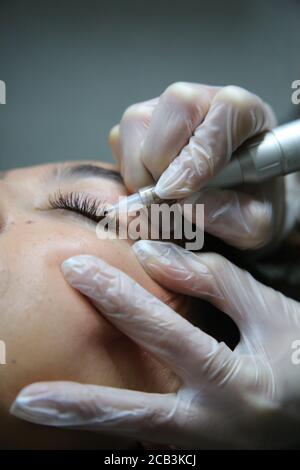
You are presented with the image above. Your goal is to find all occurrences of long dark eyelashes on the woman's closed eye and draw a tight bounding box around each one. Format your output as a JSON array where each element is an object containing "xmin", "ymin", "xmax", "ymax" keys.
[{"xmin": 49, "ymin": 191, "xmax": 106, "ymax": 222}]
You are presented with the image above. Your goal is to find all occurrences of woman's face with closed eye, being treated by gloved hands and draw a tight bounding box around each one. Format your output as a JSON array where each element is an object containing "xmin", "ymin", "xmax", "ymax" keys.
[{"xmin": 0, "ymin": 162, "xmax": 182, "ymax": 448}]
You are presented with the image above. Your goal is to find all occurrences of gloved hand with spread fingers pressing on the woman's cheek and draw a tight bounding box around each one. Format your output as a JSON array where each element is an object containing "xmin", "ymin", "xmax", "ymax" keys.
[{"xmin": 12, "ymin": 241, "xmax": 300, "ymax": 448}]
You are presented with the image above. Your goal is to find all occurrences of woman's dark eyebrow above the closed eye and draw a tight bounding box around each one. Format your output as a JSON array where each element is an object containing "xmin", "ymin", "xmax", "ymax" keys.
[{"xmin": 52, "ymin": 164, "xmax": 124, "ymax": 184}]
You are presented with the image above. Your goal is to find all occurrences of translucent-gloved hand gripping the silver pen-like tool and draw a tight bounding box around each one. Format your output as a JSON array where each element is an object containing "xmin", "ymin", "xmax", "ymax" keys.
[{"xmin": 109, "ymin": 82, "xmax": 285, "ymax": 249}]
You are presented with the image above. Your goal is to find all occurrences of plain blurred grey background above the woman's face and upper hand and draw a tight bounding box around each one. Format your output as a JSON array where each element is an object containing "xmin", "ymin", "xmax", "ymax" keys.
[{"xmin": 0, "ymin": 0, "xmax": 300, "ymax": 169}]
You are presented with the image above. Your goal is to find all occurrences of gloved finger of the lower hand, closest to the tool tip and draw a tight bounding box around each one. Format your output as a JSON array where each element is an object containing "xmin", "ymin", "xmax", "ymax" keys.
[{"xmin": 133, "ymin": 240, "xmax": 280, "ymax": 332}]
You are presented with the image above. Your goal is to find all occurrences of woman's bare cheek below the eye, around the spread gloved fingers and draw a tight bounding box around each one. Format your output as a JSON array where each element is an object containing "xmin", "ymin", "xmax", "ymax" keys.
[{"xmin": 0, "ymin": 222, "xmax": 182, "ymax": 404}]
